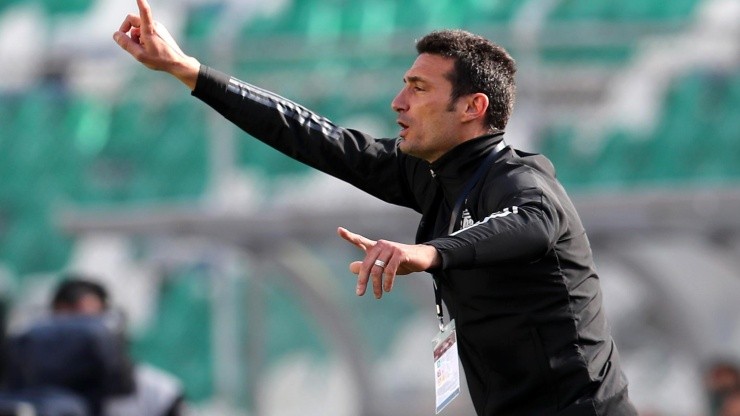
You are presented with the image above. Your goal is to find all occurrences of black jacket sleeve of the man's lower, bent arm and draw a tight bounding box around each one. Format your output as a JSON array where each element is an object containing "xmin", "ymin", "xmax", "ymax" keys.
[{"xmin": 426, "ymin": 183, "xmax": 560, "ymax": 269}]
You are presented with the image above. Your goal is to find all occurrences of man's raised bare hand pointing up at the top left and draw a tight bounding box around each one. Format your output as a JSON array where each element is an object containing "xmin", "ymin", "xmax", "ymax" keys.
[{"xmin": 113, "ymin": 0, "xmax": 200, "ymax": 90}]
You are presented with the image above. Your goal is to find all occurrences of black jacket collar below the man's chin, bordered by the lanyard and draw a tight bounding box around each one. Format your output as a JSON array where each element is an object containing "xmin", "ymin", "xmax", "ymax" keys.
[{"xmin": 429, "ymin": 132, "xmax": 504, "ymax": 206}]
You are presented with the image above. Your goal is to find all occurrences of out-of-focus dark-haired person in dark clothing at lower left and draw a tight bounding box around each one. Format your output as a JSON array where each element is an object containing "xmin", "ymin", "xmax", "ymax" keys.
[{"xmin": 2, "ymin": 274, "xmax": 133, "ymax": 416}]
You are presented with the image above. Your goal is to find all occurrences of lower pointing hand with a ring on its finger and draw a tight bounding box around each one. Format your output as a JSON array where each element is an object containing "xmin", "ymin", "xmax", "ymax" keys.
[{"xmin": 337, "ymin": 227, "xmax": 441, "ymax": 299}]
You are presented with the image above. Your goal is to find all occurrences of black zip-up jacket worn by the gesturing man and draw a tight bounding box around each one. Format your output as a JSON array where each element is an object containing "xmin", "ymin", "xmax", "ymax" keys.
[{"xmin": 193, "ymin": 66, "xmax": 636, "ymax": 415}]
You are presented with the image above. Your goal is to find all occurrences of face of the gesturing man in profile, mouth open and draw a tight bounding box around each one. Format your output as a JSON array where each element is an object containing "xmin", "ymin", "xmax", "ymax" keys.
[{"xmin": 391, "ymin": 53, "xmax": 463, "ymax": 162}]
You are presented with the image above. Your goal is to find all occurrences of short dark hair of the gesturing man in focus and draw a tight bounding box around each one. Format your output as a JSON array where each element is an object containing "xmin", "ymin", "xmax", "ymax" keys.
[{"xmin": 416, "ymin": 30, "xmax": 516, "ymax": 130}]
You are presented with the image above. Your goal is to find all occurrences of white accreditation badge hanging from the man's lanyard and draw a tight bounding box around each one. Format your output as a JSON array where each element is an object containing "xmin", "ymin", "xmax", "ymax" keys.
[{"xmin": 432, "ymin": 319, "xmax": 460, "ymax": 414}]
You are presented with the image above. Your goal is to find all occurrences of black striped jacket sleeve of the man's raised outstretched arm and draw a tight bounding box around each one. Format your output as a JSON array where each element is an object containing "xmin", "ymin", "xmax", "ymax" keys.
[{"xmin": 192, "ymin": 66, "xmax": 418, "ymax": 210}]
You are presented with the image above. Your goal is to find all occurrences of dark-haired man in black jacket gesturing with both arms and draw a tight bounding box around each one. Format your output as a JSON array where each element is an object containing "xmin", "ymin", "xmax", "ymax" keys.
[{"xmin": 113, "ymin": 0, "xmax": 636, "ymax": 415}]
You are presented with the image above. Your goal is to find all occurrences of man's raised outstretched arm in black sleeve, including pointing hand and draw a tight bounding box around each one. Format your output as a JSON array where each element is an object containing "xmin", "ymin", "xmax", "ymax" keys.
[{"xmin": 113, "ymin": 0, "xmax": 429, "ymax": 210}]
